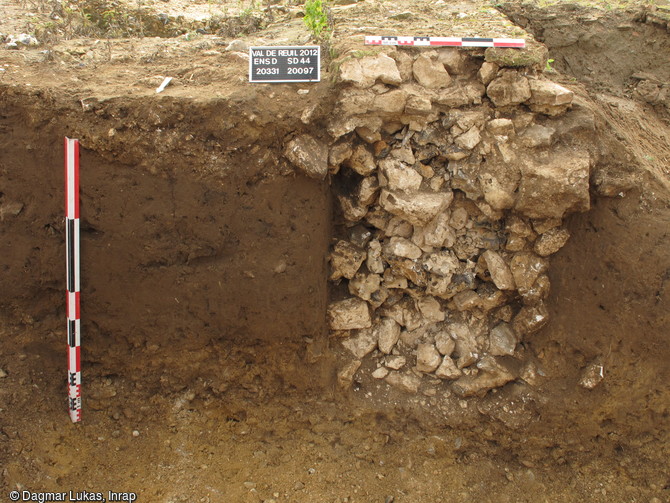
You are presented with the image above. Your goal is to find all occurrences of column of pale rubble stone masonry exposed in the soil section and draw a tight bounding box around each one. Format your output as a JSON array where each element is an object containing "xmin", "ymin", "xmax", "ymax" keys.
[{"xmin": 304, "ymin": 48, "xmax": 594, "ymax": 397}]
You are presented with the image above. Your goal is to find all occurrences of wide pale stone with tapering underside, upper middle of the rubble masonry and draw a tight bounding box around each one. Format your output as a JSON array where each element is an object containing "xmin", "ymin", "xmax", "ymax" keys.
[{"xmin": 379, "ymin": 189, "xmax": 454, "ymax": 225}]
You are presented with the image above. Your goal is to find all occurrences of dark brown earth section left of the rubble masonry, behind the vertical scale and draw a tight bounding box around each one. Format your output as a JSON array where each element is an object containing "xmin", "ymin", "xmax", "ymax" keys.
[{"xmin": 0, "ymin": 88, "xmax": 330, "ymax": 365}]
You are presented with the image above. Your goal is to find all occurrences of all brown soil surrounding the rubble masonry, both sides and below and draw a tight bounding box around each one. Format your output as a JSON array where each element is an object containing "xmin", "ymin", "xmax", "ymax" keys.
[{"xmin": 0, "ymin": 1, "xmax": 670, "ymax": 503}]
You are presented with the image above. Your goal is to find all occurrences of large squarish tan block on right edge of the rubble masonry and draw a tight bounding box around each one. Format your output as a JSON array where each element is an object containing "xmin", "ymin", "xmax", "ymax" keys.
[{"xmin": 515, "ymin": 148, "xmax": 590, "ymax": 218}]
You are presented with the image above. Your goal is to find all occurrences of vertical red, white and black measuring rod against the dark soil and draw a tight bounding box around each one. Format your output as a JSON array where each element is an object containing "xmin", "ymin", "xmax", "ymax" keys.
[{"xmin": 65, "ymin": 138, "xmax": 81, "ymax": 423}]
